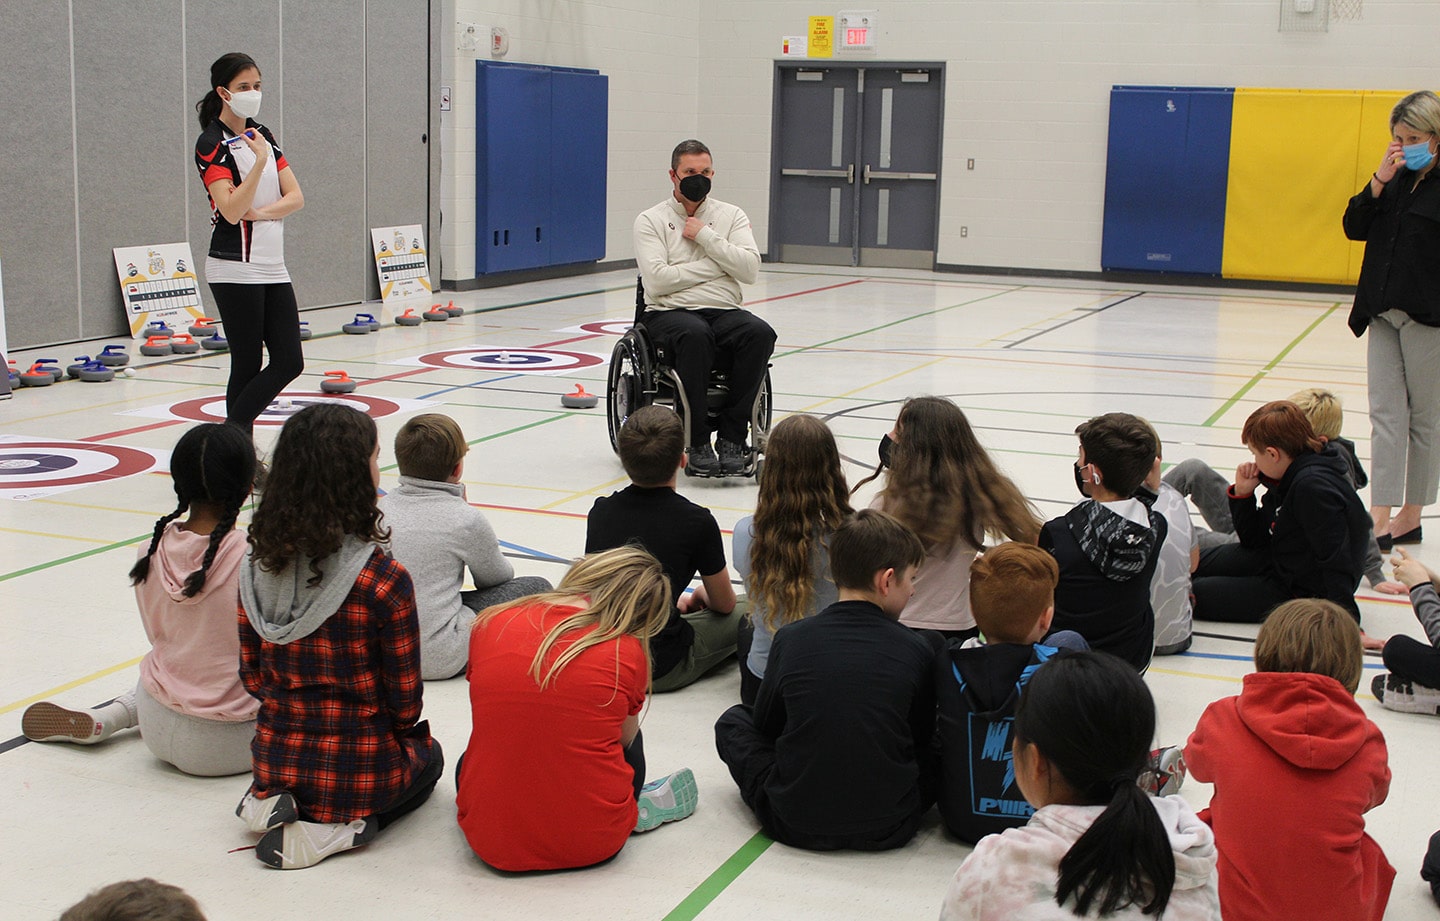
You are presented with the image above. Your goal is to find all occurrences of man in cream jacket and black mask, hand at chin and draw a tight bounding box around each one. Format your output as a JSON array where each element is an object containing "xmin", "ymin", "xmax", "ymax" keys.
[{"xmin": 635, "ymin": 140, "xmax": 775, "ymax": 476}]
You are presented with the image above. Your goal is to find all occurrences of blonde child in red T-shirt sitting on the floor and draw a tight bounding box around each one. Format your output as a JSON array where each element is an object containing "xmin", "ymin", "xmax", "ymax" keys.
[{"xmin": 455, "ymin": 547, "xmax": 698, "ymax": 871}]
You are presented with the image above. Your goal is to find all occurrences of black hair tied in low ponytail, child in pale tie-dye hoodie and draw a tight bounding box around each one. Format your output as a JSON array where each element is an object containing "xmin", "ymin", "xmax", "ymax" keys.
[{"xmin": 1014, "ymin": 652, "xmax": 1175, "ymax": 917}]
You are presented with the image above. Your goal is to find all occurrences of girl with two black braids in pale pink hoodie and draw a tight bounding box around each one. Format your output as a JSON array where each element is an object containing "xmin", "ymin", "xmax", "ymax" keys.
[{"xmin": 20, "ymin": 423, "xmax": 259, "ymax": 777}]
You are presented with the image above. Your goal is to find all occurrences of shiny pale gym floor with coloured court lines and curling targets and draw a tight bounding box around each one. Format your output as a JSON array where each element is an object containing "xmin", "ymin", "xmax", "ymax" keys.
[{"xmin": 0, "ymin": 266, "xmax": 1440, "ymax": 921}]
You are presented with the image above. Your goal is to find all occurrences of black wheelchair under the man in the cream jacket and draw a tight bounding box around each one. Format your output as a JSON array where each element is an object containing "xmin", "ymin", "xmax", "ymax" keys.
[{"xmin": 605, "ymin": 279, "xmax": 773, "ymax": 476}]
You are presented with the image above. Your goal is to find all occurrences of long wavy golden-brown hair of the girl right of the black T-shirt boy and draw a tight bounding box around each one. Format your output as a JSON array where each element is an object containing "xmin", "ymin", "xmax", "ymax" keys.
[{"xmin": 750, "ymin": 416, "xmax": 852, "ymax": 633}]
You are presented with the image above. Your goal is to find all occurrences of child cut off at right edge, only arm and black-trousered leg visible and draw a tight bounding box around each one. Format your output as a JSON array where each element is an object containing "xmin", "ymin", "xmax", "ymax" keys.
[{"xmin": 1369, "ymin": 547, "xmax": 1440, "ymax": 717}]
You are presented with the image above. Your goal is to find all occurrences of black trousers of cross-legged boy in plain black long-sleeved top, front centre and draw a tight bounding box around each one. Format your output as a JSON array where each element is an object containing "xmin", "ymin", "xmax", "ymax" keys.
[{"xmin": 716, "ymin": 704, "xmax": 935, "ymax": 850}]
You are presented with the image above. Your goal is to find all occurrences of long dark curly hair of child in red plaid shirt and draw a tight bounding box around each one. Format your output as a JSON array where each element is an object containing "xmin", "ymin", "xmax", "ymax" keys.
[{"xmin": 251, "ymin": 403, "xmax": 390, "ymax": 586}]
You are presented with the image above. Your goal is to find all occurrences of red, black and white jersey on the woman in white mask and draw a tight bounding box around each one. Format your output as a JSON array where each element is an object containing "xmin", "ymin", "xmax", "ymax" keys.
[{"xmin": 194, "ymin": 119, "xmax": 289, "ymax": 266}]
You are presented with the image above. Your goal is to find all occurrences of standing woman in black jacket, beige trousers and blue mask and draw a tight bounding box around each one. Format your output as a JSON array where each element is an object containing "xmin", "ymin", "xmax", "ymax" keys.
[{"xmin": 1345, "ymin": 91, "xmax": 1440, "ymax": 551}]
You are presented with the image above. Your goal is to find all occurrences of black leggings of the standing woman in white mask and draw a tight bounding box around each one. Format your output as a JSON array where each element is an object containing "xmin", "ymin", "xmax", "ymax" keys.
[{"xmin": 210, "ymin": 282, "xmax": 305, "ymax": 432}]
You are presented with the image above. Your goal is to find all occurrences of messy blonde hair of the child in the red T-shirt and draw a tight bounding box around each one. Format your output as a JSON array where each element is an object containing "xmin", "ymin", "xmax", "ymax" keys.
[{"xmin": 474, "ymin": 545, "xmax": 670, "ymax": 688}]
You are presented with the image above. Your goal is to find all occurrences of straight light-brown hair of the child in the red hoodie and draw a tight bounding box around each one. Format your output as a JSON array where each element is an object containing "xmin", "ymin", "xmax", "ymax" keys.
[{"xmin": 1256, "ymin": 599, "xmax": 1365, "ymax": 694}]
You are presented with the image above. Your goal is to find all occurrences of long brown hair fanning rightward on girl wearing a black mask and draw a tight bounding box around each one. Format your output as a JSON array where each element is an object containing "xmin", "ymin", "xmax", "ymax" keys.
[{"xmin": 855, "ymin": 397, "xmax": 1043, "ymax": 551}]
